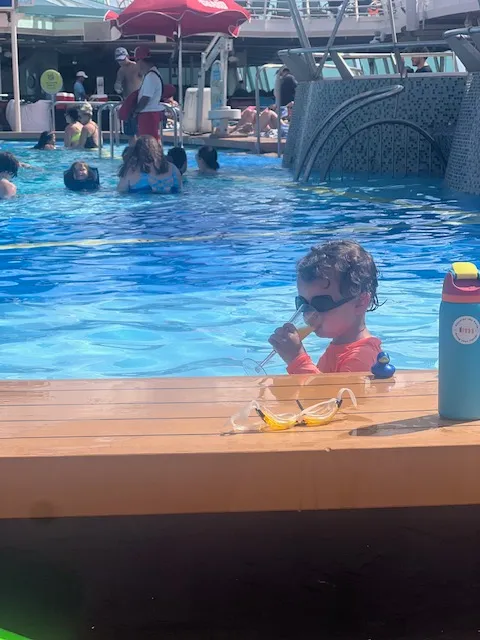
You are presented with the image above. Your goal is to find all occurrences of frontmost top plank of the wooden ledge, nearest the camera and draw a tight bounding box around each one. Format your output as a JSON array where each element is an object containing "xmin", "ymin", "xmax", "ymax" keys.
[{"xmin": 0, "ymin": 410, "xmax": 480, "ymax": 459}]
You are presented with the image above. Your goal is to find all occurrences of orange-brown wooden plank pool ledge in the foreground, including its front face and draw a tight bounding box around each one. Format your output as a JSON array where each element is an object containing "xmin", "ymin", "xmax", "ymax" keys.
[{"xmin": 0, "ymin": 371, "xmax": 480, "ymax": 518}]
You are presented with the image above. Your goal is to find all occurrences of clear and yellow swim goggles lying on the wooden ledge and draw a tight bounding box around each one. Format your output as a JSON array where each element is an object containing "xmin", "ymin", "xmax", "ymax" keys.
[{"xmin": 227, "ymin": 388, "xmax": 357, "ymax": 434}]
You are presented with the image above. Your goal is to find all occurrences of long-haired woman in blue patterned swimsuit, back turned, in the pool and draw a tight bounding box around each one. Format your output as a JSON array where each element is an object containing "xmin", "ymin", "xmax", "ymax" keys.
[{"xmin": 117, "ymin": 136, "xmax": 182, "ymax": 194}]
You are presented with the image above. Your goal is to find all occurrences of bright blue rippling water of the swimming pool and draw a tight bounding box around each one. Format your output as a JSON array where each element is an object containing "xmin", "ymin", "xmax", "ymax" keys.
[{"xmin": 0, "ymin": 143, "xmax": 480, "ymax": 378}]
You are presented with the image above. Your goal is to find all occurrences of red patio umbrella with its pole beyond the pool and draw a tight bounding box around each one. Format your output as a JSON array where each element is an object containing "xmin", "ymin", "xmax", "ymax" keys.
[{"xmin": 117, "ymin": 0, "xmax": 250, "ymax": 104}]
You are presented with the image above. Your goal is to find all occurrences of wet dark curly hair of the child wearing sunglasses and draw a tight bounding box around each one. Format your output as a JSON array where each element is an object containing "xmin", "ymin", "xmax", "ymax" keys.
[{"xmin": 297, "ymin": 240, "xmax": 380, "ymax": 311}]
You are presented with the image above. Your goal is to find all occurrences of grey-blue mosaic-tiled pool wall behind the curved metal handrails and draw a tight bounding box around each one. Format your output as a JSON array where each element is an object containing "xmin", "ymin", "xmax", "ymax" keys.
[{"xmin": 284, "ymin": 73, "xmax": 464, "ymax": 177}]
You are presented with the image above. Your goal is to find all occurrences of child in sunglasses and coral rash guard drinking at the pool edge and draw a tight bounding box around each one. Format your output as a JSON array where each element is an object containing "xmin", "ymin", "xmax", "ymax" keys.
[{"xmin": 269, "ymin": 240, "xmax": 381, "ymax": 373}]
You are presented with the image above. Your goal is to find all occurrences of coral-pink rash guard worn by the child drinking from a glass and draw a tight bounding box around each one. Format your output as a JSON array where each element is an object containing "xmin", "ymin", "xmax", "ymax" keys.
[{"xmin": 287, "ymin": 336, "xmax": 382, "ymax": 373}]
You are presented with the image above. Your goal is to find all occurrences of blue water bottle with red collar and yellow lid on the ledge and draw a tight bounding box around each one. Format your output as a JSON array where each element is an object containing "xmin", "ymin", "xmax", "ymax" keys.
[{"xmin": 438, "ymin": 262, "xmax": 480, "ymax": 420}]
